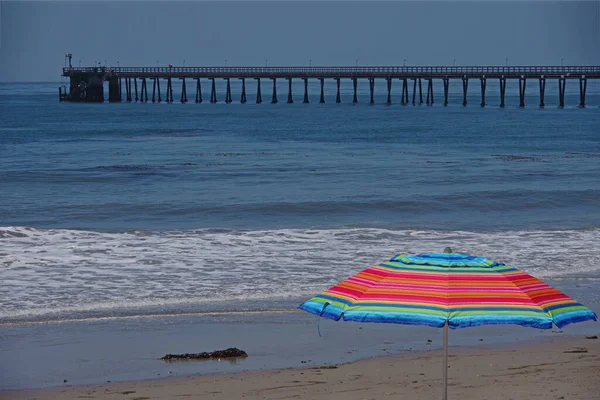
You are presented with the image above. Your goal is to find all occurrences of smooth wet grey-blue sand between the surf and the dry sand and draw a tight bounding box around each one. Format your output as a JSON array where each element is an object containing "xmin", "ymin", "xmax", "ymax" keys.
[{"xmin": 0, "ymin": 278, "xmax": 600, "ymax": 389}]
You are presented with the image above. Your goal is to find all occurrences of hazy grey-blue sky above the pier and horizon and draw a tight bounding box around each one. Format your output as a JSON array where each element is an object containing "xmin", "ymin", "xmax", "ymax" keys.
[{"xmin": 0, "ymin": 0, "xmax": 600, "ymax": 81}]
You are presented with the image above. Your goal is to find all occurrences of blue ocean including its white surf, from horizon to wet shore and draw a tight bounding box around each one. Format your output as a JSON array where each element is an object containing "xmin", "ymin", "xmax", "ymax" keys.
[{"xmin": 0, "ymin": 81, "xmax": 600, "ymax": 325}]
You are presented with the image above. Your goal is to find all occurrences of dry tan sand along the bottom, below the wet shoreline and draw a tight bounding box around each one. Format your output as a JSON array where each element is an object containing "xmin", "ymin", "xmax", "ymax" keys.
[{"xmin": 0, "ymin": 337, "xmax": 600, "ymax": 400}]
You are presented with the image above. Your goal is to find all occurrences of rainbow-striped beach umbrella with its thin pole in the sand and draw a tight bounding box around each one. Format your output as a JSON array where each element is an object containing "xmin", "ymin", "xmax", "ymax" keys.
[{"xmin": 299, "ymin": 249, "xmax": 597, "ymax": 400}]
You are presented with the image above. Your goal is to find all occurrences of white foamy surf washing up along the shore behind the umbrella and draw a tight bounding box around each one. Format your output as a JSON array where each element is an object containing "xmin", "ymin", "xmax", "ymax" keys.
[{"xmin": 0, "ymin": 227, "xmax": 600, "ymax": 321}]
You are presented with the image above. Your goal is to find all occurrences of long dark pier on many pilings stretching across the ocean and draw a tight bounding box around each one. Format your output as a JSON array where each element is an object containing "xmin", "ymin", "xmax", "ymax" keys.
[{"xmin": 59, "ymin": 64, "xmax": 600, "ymax": 107}]
